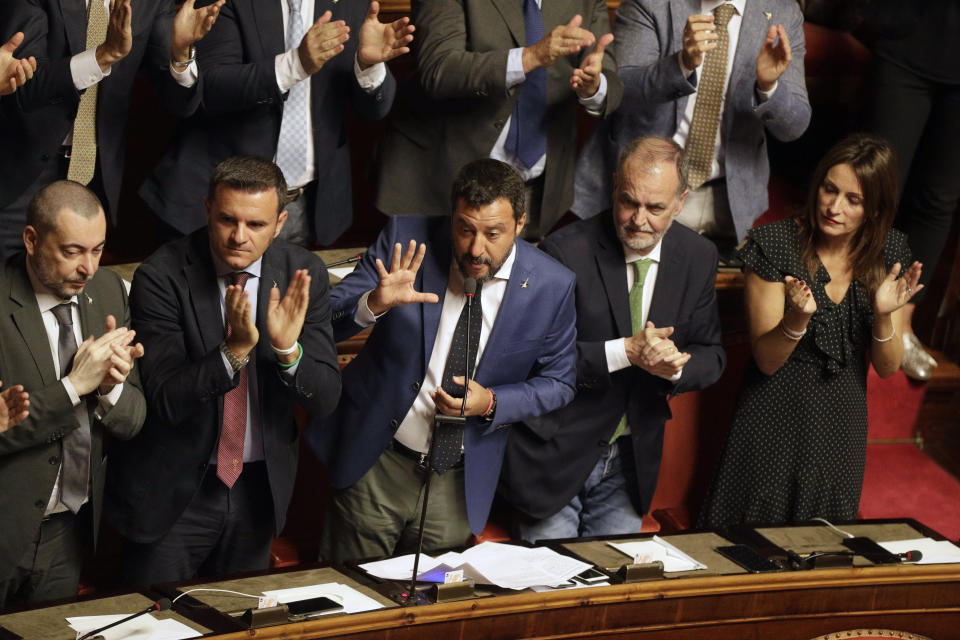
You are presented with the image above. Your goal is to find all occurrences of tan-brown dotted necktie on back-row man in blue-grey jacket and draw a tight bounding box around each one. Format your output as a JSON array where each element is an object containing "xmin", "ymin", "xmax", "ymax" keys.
[{"xmin": 686, "ymin": 4, "xmax": 737, "ymax": 189}]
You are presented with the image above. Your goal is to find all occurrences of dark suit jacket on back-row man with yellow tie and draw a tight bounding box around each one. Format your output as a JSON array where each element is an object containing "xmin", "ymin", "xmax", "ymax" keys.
[{"xmin": 0, "ymin": 0, "xmax": 201, "ymax": 223}]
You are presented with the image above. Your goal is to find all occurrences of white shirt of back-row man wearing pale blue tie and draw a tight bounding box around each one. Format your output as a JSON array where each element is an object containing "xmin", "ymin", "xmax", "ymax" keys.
[{"xmin": 273, "ymin": 0, "xmax": 387, "ymax": 189}]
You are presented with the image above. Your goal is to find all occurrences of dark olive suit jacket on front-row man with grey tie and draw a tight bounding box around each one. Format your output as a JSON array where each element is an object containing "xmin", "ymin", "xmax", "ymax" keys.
[{"xmin": 0, "ymin": 253, "xmax": 146, "ymax": 581}]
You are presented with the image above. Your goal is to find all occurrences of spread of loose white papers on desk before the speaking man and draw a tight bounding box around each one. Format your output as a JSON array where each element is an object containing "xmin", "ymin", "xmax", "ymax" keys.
[{"xmin": 360, "ymin": 542, "xmax": 591, "ymax": 590}]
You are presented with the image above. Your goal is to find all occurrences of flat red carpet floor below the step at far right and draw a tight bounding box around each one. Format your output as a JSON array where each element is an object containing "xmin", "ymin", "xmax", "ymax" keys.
[{"xmin": 860, "ymin": 442, "xmax": 960, "ymax": 540}]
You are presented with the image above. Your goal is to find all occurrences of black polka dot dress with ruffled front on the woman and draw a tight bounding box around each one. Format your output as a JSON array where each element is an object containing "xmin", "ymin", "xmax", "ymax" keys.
[{"xmin": 698, "ymin": 219, "xmax": 910, "ymax": 528}]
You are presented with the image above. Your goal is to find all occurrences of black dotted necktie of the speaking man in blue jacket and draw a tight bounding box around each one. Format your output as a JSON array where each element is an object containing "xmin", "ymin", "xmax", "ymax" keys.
[{"xmin": 430, "ymin": 283, "xmax": 483, "ymax": 473}]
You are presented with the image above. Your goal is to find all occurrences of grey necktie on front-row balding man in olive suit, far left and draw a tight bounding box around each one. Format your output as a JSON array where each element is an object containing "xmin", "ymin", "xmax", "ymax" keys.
[{"xmin": 52, "ymin": 302, "xmax": 90, "ymax": 513}]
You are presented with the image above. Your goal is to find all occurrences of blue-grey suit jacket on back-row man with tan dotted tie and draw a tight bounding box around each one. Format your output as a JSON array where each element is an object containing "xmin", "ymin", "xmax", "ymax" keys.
[{"xmin": 573, "ymin": 0, "xmax": 810, "ymax": 238}]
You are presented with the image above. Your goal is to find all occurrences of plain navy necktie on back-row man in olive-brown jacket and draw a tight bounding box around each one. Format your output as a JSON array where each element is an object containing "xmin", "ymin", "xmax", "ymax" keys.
[{"xmin": 506, "ymin": 0, "xmax": 547, "ymax": 169}]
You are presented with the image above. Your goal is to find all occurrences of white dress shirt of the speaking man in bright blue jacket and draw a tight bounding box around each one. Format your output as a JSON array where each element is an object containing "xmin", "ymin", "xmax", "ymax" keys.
[{"xmin": 354, "ymin": 244, "xmax": 517, "ymax": 453}]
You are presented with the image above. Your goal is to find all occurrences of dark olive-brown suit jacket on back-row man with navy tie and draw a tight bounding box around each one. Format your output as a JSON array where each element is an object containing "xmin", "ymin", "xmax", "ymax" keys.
[{"xmin": 376, "ymin": 0, "xmax": 623, "ymax": 231}]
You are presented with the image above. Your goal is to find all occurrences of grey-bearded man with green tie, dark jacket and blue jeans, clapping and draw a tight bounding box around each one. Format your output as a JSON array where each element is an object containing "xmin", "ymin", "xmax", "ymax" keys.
[{"xmin": 499, "ymin": 138, "xmax": 726, "ymax": 542}]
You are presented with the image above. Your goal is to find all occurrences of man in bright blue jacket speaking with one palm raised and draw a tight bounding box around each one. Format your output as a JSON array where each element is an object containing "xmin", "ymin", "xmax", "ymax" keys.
[{"xmin": 308, "ymin": 159, "xmax": 576, "ymax": 562}]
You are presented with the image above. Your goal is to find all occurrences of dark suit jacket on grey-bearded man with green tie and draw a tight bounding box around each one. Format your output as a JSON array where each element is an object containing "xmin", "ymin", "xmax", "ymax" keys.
[{"xmin": 500, "ymin": 211, "xmax": 726, "ymax": 518}]
